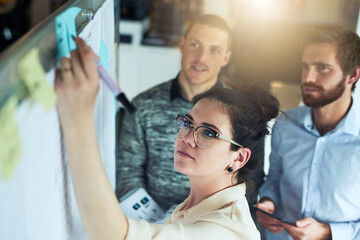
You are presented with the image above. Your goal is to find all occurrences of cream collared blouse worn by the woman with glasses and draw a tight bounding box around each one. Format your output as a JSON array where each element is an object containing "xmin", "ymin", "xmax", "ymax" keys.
[{"xmin": 126, "ymin": 184, "xmax": 260, "ymax": 240}]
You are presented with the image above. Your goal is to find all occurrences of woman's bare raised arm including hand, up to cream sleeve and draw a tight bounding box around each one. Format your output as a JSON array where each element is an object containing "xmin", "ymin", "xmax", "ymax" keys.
[{"xmin": 55, "ymin": 37, "xmax": 128, "ymax": 239}]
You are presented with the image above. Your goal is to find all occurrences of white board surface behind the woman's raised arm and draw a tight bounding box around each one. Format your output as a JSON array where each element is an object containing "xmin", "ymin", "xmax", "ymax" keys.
[{"xmin": 0, "ymin": 0, "xmax": 116, "ymax": 239}]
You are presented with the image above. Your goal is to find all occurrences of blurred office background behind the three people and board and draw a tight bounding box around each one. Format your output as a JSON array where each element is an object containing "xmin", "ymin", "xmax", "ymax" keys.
[{"xmin": 0, "ymin": 0, "xmax": 360, "ymax": 172}]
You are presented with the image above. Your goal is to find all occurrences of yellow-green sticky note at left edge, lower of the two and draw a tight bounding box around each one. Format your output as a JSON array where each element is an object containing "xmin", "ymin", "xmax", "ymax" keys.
[{"xmin": 0, "ymin": 96, "xmax": 22, "ymax": 179}]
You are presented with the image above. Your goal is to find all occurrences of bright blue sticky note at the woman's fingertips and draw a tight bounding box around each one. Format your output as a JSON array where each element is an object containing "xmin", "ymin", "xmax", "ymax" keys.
[{"xmin": 55, "ymin": 7, "xmax": 81, "ymax": 60}]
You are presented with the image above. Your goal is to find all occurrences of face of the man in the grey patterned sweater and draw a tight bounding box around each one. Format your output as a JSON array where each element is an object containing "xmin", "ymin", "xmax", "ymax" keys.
[{"xmin": 179, "ymin": 24, "xmax": 231, "ymax": 85}]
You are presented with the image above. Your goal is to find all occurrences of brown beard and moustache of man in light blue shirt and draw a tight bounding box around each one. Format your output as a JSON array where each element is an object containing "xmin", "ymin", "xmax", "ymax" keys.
[{"xmin": 301, "ymin": 76, "xmax": 345, "ymax": 108}]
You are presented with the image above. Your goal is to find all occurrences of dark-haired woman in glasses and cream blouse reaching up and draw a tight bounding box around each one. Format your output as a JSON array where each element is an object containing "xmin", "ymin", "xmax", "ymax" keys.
[{"xmin": 55, "ymin": 38, "xmax": 279, "ymax": 240}]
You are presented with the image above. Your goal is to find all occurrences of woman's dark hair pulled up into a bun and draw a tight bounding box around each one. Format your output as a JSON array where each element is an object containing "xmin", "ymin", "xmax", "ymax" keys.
[{"xmin": 192, "ymin": 85, "xmax": 280, "ymax": 193}]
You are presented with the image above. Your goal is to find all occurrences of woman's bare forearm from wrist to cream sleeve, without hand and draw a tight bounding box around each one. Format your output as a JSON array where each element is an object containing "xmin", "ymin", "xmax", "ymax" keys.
[{"xmin": 64, "ymin": 121, "xmax": 128, "ymax": 239}]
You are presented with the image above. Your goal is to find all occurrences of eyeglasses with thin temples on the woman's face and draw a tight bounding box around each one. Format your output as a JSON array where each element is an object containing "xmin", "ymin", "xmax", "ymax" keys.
[{"xmin": 175, "ymin": 114, "xmax": 243, "ymax": 148}]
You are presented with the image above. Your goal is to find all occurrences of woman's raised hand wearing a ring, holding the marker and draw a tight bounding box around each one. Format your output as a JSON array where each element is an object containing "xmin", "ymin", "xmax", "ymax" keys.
[{"xmin": 55, "ymin": 37, "xmax": 99, "ymax": 129}]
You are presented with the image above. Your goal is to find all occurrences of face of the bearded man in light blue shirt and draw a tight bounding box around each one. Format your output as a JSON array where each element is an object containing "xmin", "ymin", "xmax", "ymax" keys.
[{"xmin": 301, "ymin": 43, "xmax": 346, "ymax": 108}]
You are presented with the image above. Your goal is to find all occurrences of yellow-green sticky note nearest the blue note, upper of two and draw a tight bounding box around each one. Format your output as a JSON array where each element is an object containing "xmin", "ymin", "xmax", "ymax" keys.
[{"xmin": 18, "ymin": 48, "xmax": 57, "ymax": 112}]
